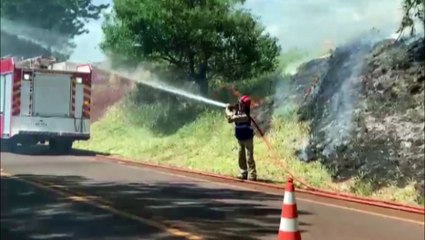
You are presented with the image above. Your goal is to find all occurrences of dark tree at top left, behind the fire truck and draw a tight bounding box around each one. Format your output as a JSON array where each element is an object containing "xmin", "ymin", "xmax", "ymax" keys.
[{"xmin": 1, "ymin": 0, "xmax": 109, "ymax": 60}]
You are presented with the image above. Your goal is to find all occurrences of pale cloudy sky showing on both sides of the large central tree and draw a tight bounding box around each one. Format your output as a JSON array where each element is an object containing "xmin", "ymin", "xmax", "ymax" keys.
[{"xmin": 70, "ymin": 0, "xmax": 402, "ymax": 62}]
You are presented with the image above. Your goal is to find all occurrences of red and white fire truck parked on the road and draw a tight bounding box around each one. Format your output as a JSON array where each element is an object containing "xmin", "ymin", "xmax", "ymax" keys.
[{"xmin": 0, "ymin": 57, "xmax": 92, "ymax": 153}]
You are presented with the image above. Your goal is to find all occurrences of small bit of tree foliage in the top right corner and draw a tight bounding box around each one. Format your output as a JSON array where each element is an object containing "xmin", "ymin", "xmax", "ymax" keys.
[{"xmin": 398, "ymin": 0, "xmax": 425, "ymax": 35}]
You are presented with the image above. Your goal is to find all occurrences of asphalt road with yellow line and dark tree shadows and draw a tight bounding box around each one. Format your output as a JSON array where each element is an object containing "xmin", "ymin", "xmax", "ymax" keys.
[{"xmin": 1, "ymin": 149, "xmax": 425, "ymax": 240}]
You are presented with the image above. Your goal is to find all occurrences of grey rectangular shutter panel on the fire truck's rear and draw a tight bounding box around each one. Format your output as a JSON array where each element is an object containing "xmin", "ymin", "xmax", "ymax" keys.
[{"xmin": 32, "ymin": 72, "xmax": 71, "ymax": 117}]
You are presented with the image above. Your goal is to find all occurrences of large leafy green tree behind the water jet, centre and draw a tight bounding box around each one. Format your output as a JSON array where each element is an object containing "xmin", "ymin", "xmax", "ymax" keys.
[{"xmin": 101, "ymin": 0, "xmax": 280, "ymax": 95}]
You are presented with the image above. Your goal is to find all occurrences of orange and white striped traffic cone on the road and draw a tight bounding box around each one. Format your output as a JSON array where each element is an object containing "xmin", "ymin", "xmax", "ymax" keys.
[{"xmin": 278, "ymin": 178, "xmax": 301, "ymax": 240}]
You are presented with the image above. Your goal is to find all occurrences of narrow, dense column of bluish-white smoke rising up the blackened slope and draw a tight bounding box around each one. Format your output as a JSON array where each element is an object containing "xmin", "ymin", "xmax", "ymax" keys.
[{"xmin": 318, "ymin": 33, "xmax": 382, "ymax": 155}]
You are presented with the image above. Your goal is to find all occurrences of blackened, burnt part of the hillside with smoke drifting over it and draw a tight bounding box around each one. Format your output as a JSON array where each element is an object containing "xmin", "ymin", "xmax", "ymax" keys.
[{"xmin": 284, "ymin": 35, "xmax": 425, "ymax": 201}]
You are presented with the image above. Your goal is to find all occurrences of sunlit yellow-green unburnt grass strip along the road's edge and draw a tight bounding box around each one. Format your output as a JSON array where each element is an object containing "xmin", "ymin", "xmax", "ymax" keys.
[{"xmin": 75, "ymin": 100, "xmax": 423, "ymax": 205}]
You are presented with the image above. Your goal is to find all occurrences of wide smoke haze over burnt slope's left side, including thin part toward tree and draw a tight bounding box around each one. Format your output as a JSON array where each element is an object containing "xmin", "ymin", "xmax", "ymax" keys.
[{"xmin": 280, "ymin": 31, "xmax": 384, "ymax": 161}]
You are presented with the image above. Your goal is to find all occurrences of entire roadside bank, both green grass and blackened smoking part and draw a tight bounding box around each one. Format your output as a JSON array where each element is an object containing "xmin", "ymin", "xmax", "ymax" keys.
[{"xmin": 77, "ymin": 36, "xmax": 425, "ymax": 204}]
